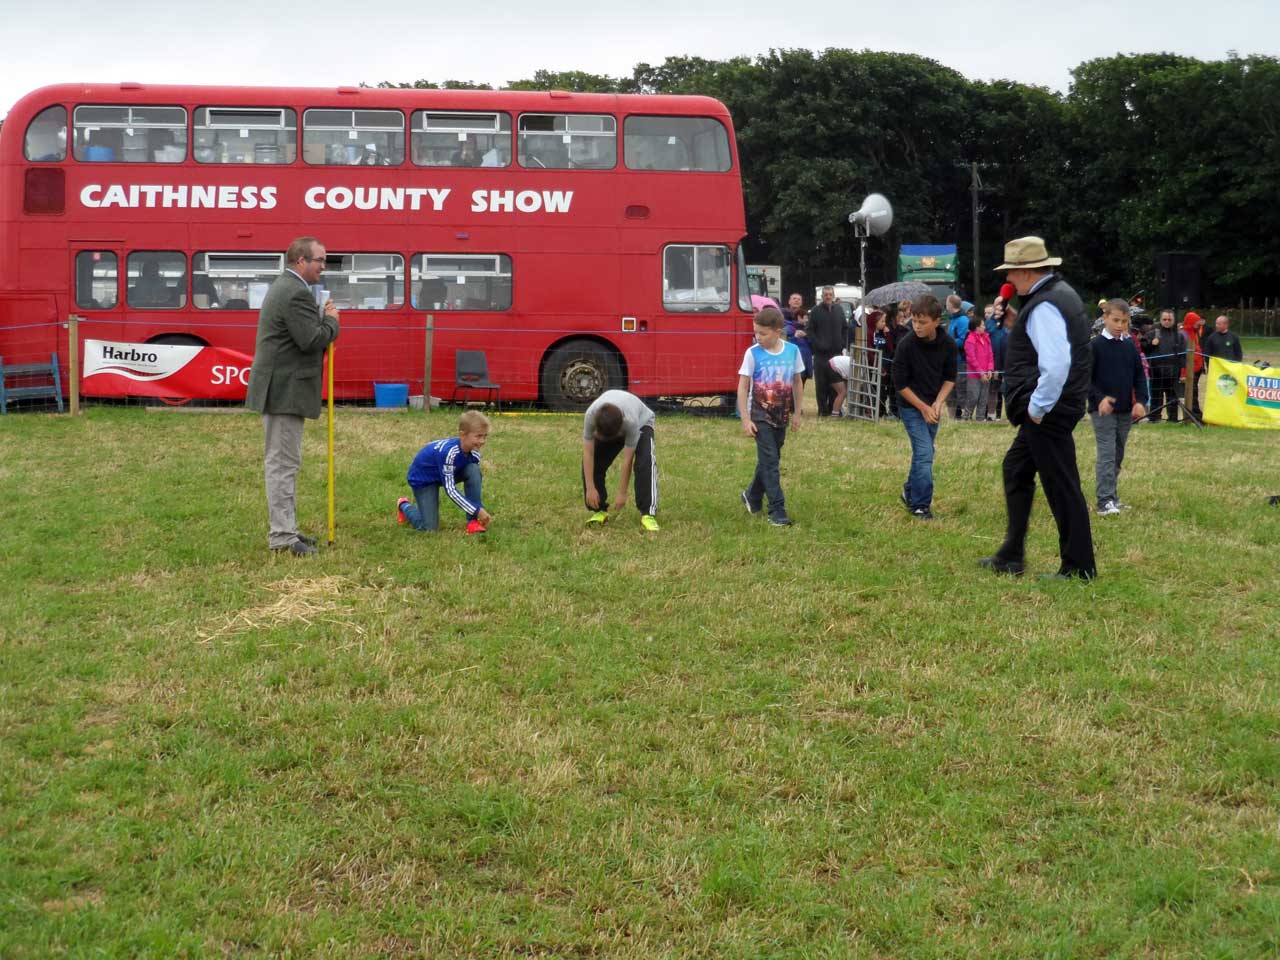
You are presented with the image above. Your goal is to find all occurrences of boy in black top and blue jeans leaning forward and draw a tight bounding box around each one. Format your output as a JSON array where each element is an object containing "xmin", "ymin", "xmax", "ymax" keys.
[{"xmin": 893, "ymin": 293, "xmax": 956, "ymax": 520}]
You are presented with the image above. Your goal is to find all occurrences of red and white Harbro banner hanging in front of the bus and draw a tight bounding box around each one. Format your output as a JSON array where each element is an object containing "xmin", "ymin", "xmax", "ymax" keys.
[{"xmin": 81, "ymin": 340, "xmax": 253, "ymax": 401}]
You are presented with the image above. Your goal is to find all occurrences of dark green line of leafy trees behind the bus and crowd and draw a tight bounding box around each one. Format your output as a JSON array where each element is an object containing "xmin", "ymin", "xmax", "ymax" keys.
[{"xmin": 379, "ymin": 49, "xmax": 1280, "ymax": 303}]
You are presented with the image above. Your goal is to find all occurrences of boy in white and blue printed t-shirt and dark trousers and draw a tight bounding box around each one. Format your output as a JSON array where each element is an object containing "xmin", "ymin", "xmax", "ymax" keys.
[{"xmin": 737, "ymin": 307, "xmax": 804, "ymax": 526}]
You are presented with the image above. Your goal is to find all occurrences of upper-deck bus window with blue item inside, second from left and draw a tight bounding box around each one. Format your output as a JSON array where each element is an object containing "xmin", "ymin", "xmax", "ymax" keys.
[{"xmin": 73, "ymin": 105, "xmax": 187, "ymax": 164}]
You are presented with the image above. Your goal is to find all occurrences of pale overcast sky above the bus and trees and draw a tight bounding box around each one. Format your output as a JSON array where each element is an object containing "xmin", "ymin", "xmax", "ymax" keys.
[{"xmin": 0, "ymin": 0, "xmax": 1280, "ymax": 116}]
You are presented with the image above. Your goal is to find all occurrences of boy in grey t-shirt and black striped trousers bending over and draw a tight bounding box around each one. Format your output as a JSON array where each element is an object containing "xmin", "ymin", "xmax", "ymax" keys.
[{"xmin": 582, "ymin": 390, "xmax": 658, "ymax": 532}]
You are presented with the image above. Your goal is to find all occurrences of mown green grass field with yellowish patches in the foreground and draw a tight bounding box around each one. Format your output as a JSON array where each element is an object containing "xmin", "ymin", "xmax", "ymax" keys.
[{"xmin": 0, "ymin": 408, "xmax": 1280, "ymax": 959}]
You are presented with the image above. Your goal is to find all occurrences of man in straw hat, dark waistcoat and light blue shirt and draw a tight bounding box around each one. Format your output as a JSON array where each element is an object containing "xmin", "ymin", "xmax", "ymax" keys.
[{"xmin": 979, "ymin": 237, "xmax": 1098, "ymax": 580}]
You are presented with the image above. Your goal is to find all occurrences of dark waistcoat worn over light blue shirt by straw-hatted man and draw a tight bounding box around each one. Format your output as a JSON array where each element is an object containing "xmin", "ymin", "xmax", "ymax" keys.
[{"xmin": 1005, "ymin": 276, "xmax": 1093, "ymax": 426}]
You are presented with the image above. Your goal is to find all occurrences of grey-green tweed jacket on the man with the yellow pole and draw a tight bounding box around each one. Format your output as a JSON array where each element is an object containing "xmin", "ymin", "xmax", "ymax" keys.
[{"xmin": 244, "ymin": 270, "xmax": 338, "ymax": 420}]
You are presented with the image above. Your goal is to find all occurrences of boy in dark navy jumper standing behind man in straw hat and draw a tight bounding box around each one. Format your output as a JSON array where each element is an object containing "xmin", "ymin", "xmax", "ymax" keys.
[{"xmin": 1089, "ymin": 298, "xmax": 1151, "ymax": 517}]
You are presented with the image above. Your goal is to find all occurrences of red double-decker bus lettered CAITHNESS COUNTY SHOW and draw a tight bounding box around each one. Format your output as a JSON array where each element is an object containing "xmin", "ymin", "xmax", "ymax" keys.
[{"xmin": 0, "ymin": 83, "xmax": 751, "ymax": 408}]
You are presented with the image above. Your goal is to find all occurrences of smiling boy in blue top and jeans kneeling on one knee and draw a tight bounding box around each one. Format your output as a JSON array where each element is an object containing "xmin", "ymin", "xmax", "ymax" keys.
[{"xmin": 396, "ymin": 410, "xmax": 493, "ymax": 534}]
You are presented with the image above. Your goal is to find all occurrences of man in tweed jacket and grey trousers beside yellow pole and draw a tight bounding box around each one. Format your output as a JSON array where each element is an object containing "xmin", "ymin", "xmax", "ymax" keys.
[{"xmin": 244, "ymin": 237, "xmax": 338, "ymax": 557}]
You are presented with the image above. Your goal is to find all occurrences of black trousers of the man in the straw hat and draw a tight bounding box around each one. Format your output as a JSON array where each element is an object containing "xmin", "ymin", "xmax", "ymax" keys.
[{"xmin": 996, "ymin": 420, "xmax": 1098, "ymax": 577}]
